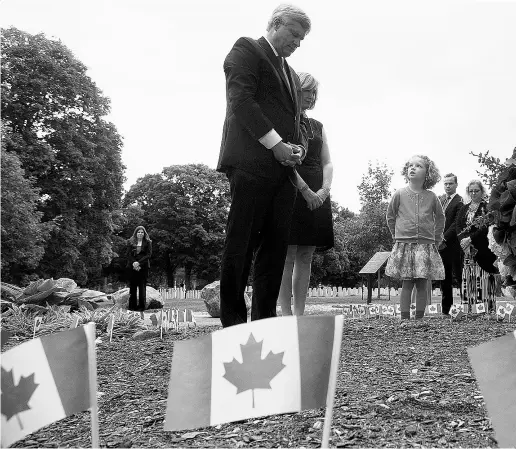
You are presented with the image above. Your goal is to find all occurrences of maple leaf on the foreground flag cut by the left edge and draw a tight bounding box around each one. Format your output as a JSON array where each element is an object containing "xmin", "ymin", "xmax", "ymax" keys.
[{"xmin": 1, "ymin": 366, "xmax": 39, "ymax": 429}]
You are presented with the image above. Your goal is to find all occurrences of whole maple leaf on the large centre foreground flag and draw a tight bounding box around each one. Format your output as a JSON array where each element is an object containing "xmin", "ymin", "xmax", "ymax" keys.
[{"xmin": 223, "ymin": 334, "xmax": 286, "ymax": 408}]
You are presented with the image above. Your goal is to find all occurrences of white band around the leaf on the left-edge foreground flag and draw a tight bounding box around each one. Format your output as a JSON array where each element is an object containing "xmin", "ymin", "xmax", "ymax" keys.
[{"xmin": 2, "ymin": 338, "xmax": 66, "ymax": 447}]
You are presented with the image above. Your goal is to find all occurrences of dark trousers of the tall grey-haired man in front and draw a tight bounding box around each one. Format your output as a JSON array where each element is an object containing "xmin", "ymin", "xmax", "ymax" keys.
[{"xmin": 220, "ymin": 166, "xmax": 296, "ymax": 327}]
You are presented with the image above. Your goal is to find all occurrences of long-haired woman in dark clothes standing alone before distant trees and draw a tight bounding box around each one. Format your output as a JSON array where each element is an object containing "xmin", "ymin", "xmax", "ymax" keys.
[{"xmin": 127, "ymin": 226, "xmax": 152, "ymax": 311}]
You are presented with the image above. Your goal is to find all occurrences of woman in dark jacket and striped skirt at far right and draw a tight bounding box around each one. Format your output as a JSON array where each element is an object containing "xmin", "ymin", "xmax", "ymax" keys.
[{"xmin": 456, "ymin": 180, "xmax": 498, "ymax": 312}]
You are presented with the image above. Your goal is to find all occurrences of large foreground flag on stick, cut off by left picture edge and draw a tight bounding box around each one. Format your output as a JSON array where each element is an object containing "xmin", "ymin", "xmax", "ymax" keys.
[{"xmin": 1, "ymin": 323, "xmax": 100, "ymax": 447}]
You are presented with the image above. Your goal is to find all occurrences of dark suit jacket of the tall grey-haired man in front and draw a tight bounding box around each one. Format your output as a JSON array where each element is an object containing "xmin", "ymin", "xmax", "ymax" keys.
[{"xmin": 217, "ymin": 37, "xmax": 308, "ymax": 178}]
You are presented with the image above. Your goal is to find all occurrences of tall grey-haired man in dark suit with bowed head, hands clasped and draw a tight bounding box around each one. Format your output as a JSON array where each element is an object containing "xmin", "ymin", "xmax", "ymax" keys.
[{"xmin": 217, "ymin": 5, "xmax": 311, "ymax": 327}]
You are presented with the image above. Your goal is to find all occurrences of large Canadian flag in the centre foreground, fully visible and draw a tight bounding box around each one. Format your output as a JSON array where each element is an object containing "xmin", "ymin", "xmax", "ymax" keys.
[{"xmin": 164, "ymin": 315, "xmax": 343, "ymax": 431}]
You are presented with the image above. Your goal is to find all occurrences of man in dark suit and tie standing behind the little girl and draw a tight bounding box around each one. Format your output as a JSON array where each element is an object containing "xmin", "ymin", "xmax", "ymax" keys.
[{"xmin": 439, "ymin": 173, "xmax": 463, "ymax": 315}]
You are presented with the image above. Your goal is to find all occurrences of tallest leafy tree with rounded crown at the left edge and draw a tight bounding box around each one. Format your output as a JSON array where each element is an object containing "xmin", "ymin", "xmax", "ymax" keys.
[{"xmin": 1, "ymin": 28, "xmax": 124, "ymax": 284}]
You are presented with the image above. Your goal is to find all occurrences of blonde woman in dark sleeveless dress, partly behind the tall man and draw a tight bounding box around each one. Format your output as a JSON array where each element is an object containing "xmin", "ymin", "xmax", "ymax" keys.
[{"xmin": 279, "ymin": 73, "xmax": 333, "ymax": 316}]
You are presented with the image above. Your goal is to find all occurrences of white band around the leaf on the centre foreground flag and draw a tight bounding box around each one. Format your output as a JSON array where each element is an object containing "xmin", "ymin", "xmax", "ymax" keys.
[{"xmin": 210, "ymin": 316, "xmax": 301, "ymax": 425}]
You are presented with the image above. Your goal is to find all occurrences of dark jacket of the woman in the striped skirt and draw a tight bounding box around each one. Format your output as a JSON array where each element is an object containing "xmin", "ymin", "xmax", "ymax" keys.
[{"xmin": 456, "ymin": 201, "xmax": 498, "ymax": 273}]
